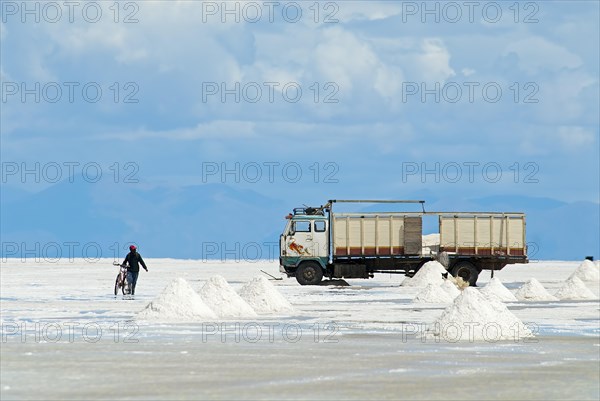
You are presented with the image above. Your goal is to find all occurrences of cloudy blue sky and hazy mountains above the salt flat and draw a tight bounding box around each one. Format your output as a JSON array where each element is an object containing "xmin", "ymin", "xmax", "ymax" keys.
[{"xmin": 0, "ymin": 1, "xmax": 600, "ymax": 260}]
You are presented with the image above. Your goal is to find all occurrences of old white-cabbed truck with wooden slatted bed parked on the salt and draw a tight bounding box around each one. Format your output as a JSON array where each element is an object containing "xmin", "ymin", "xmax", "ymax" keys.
[{"xmin": 279, "ymin": 200, "xmax": 528, "ymax": 286}]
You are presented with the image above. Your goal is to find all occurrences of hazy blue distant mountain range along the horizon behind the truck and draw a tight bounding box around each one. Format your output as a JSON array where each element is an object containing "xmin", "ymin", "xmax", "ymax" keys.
[{"xmin": 0, "ymin": 181, "xmax": 600, "ymax": 260}]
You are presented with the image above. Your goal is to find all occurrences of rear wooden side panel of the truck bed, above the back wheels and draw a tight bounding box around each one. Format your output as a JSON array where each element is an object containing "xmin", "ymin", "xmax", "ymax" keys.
[{"xmin": 439, "ymin": 213, "xmax": 527, "ymax": 256}]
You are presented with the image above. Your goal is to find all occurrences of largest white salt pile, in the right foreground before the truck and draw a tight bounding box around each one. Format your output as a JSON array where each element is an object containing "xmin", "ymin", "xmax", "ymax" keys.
[{"xmin": 427, "ymin": 288, "xmax": 533, "ymax": 342}]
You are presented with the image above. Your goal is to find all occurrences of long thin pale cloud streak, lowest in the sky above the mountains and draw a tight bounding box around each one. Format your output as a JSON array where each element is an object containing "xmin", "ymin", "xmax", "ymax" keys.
[{"xmin": 92, "ymin": 120, "xmax": 416, "ymax": 158}]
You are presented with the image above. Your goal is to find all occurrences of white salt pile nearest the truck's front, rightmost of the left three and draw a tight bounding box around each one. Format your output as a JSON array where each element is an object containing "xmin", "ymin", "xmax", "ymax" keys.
[{"xmin": 239, "ymin": 277, "xmax": 294, "ymax": 313}]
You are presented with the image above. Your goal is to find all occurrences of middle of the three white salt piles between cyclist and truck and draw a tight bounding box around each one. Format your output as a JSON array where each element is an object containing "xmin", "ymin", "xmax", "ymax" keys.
[{"xmin": 198, "ymin": 275, "xmax": 257, "ymax": 318}]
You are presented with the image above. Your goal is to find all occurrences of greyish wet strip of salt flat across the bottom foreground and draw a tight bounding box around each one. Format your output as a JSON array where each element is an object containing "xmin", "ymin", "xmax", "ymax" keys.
[{"xmin": 0, "ymin": 332, "xmax": 600, "ymax": 400}]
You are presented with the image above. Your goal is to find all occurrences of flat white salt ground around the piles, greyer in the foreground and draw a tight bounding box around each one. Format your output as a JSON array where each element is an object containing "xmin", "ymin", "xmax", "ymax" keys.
[{"xmin": 0, "ymin": 260, "xmax": 600, "ymax": 400}]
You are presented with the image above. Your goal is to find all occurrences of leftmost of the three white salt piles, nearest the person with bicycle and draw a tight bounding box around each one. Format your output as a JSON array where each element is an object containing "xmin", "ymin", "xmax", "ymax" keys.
[{"xmin": 137, "ymin": 278, "xmax": 217, "ymax": 321}]
